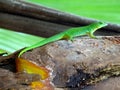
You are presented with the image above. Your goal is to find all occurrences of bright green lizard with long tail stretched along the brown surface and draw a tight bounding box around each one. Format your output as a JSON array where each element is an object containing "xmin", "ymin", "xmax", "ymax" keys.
[{"xmin": 18, "ymin": 22, "xmax": 107, "ymax": 57}]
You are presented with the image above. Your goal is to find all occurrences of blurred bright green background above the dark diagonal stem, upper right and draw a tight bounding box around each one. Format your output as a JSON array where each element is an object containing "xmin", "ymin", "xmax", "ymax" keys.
[{"xmin": 27, "ymin": 0, "xmax": 120, "ymax": 24}]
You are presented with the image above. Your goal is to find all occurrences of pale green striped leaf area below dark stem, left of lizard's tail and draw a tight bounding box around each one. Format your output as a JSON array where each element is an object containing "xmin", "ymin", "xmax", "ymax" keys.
[{"xmin": 0, "ymin": 29, "xmax": 44, "ymax": 53}]
